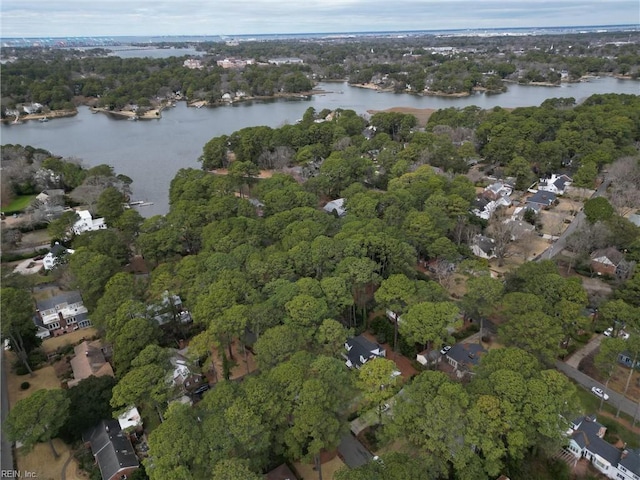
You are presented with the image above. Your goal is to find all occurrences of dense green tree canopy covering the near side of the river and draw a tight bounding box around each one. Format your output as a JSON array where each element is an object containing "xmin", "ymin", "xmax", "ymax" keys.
[{"xmin": 2, "ymin": 95, "xmax": 640, "ymax": 480}]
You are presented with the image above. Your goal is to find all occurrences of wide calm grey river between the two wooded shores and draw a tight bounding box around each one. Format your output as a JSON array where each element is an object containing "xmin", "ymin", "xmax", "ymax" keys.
[{"xmin": 0, "ymin": 78, "xmax": 640, "ymax": 216}]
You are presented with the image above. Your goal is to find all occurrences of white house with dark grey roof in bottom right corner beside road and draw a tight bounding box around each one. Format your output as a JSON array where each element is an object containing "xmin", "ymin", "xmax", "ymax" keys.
[{"xmin": 567, "ymin": 416, "xmax": 640, "ymax": 480}]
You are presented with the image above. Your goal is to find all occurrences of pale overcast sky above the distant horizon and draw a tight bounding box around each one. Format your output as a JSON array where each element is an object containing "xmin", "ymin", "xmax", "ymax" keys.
[{"xmin": 0, "ymin": 0, "xmax": 640, "ymax": 38}]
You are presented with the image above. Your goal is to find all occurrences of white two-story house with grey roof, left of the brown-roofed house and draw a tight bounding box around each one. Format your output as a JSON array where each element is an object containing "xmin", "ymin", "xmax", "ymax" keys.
[{"xmin": 34, "ymin": 291, "xmax": 91, "ymax": 338}]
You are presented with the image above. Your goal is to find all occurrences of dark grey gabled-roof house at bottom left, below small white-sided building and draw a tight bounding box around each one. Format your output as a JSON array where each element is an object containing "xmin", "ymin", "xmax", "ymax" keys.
[{"xmin": 82, "ymin": 419, "xmax": 140, "ymax": 480}]
